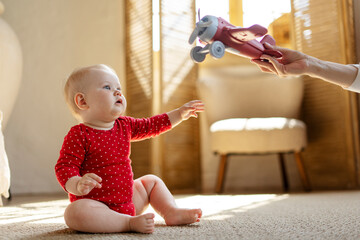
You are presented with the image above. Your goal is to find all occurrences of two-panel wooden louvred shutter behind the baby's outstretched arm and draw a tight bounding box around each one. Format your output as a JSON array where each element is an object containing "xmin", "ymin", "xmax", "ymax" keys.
[{"xmin": 126, "ymin": 0, "xmax": 201, "ymax": 192}]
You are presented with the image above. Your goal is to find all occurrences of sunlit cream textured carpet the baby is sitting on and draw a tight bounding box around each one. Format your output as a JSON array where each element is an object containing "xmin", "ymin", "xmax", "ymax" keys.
[{"xmin": 0, "ymin": 191, "xmax": 360, "ymax": 240}]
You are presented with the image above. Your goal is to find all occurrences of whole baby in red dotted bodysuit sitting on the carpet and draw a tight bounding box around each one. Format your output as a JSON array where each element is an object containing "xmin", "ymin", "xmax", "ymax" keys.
[{"xmin": 55, "ymin": 64, "xmax": 204, "ymax": 233}]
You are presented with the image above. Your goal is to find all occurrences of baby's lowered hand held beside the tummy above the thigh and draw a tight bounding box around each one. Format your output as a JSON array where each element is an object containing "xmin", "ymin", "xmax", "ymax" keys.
[{"xmin": 65, "ymin": 173, "xmax": 102, "ymax": 196}]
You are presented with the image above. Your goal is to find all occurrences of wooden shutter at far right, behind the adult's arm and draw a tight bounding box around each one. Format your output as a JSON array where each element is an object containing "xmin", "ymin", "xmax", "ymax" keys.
[{"xmin": 292, "ymin": 0, "xmax": 359, "ymax": 189}]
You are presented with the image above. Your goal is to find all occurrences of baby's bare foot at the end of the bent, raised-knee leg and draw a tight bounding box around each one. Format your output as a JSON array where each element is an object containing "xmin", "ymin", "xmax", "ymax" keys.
[{"xmin": 164, "ymin": 208, "xmax": 202, "ymax": 226}]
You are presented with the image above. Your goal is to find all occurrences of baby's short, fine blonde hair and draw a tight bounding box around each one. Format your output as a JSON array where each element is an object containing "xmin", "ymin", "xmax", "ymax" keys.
[{"xmin": 64, "ymin": 64, "xmax": 116, "ymax": 119}]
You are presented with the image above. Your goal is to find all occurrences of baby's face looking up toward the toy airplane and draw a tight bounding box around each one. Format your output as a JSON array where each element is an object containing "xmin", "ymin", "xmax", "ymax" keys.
[{"xmin": 84, "ymin": 67, "xmax": 126, "ymax": 122}]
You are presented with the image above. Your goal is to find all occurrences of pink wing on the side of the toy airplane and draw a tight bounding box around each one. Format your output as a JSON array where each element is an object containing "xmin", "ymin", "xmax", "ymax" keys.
[{"xmin": 228, "ymin": 24, "xmax": 267, "ymax": 42}]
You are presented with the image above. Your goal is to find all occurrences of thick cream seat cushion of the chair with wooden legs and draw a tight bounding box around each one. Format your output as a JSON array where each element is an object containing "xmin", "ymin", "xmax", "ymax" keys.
[{"xmin": 210, "ymin": 117, "xmax": 307, "ymax": 154}]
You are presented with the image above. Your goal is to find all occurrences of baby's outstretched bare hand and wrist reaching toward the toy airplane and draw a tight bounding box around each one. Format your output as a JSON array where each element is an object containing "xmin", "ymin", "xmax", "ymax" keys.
[{"xmin": 167, "ymin": 100, "xmax": 205, "ymax": 127}]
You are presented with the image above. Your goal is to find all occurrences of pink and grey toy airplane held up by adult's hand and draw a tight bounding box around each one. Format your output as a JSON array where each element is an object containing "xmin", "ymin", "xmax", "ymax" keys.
[{"xmin": 189, "ymin": 12, "xmax": 282, "ymax": 63}]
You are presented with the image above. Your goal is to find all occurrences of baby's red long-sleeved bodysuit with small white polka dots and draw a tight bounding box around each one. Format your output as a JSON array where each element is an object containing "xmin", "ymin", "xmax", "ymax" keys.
[{"xmin": 55, "ymin": 113, "xmax": 171, "ymax": 216}]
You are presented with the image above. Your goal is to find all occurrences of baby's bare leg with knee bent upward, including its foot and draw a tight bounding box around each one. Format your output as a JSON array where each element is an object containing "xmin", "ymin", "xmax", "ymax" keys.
[{"xmin": 133, "ymin": 175, "xmax": 202, "ymax": 225}]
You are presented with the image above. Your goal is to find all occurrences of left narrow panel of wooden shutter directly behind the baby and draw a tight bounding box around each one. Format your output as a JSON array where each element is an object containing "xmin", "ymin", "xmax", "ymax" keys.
[{"xmin": 125, "ymin": 0, "xmax": 153, "ymax": 178}]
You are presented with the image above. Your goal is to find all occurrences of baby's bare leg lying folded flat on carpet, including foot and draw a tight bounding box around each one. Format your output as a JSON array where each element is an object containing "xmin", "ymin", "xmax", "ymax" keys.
[{"xmin": 64, "ymin": 199, "xmax": 155, "ymax": 233}]
